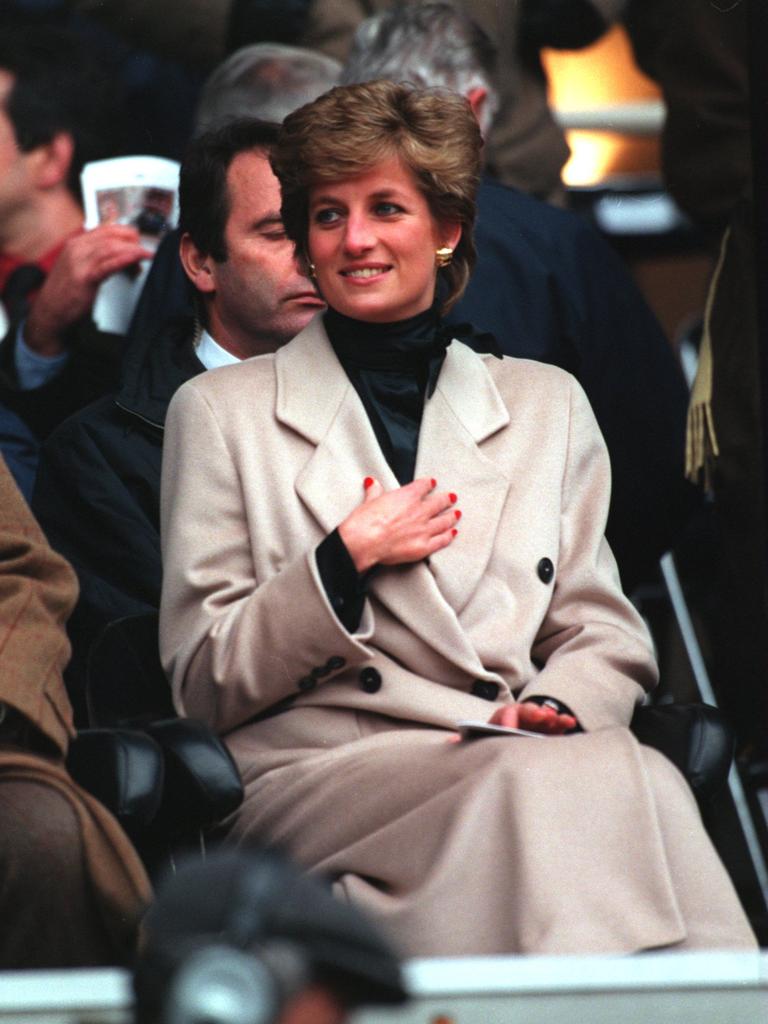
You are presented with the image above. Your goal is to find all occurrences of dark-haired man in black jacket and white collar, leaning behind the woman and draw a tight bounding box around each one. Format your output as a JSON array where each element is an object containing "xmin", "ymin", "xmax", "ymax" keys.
[{"xmin": 33, "ymin": 120, "xmax": 323, "ymax": 715}]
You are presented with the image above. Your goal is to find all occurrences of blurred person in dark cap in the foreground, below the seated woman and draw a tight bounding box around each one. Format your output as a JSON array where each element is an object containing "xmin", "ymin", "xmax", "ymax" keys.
[{"xmin": 134, "ymin": 849, "xmax": 406, "ymax": 1024}]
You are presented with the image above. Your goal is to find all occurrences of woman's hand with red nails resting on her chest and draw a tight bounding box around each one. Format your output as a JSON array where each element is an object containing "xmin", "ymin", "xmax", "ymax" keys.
[{"xmin": 339, "ymin": 477, "xmax": 461, "ymax": 572}]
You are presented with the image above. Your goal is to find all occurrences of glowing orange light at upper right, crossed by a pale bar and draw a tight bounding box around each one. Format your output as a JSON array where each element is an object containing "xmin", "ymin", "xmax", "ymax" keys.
[{"xmin": 542, "ymin": 26, "xmax": 659, "ymax": 185}]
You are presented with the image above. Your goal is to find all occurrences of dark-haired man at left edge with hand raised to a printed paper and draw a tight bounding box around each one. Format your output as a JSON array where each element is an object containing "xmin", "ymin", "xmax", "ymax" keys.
[{"xmin": 0, "ymin": 27, "xmax": 151, "ymax": 438}]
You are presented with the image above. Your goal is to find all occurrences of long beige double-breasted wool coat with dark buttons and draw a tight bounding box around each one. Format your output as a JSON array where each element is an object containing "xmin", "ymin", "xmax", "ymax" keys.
[{"xmin": 161, "ymin": 318, "xmax": 754, "ymax": 955}]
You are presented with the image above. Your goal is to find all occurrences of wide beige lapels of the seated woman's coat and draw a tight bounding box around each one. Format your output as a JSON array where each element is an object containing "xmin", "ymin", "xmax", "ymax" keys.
[{"xmin": 275, "ymin": 317, "xmax": 509, "ymax": 675}]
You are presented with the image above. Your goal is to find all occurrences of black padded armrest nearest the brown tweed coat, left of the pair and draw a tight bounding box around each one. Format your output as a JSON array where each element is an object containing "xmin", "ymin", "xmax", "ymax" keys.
[{"xmin": 67, "ymin": 729, "xmax": 165, "ymax": 838}]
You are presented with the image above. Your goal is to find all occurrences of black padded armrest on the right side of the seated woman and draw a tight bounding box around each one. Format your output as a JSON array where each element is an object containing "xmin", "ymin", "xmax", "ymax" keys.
[{"xmin": 630, "ymin": 703, "xmax": 734, "ymax": 807}]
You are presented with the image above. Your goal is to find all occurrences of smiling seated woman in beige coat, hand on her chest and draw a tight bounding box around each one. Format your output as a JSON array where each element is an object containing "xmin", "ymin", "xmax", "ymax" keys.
[{"xmin": 161, "ymin": 82, "xmax": 755, "ymax": 955}]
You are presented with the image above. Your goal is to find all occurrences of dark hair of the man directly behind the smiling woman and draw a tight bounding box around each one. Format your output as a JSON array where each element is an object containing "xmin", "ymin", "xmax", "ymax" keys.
[{"xmin": 179, "ymin": 118, "xmax": 280, "ymax": 263}]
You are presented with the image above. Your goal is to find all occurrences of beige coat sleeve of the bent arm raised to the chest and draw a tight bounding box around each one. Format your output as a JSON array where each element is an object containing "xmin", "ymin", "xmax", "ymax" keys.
[{"xmin": 160, "ymin": 381, "xmax": 373, "ymax": 732}]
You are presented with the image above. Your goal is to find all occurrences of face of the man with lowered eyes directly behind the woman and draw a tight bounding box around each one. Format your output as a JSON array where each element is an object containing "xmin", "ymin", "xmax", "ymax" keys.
[{"xmin": 209, "ymin": 150, "xmax": 324, "ymax": 357}]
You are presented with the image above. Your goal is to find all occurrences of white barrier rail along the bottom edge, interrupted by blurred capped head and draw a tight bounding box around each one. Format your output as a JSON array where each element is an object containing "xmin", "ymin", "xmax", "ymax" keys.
[{"xmin": 0, "ymin": 950, "xmax": 768, "ymax": 1024}]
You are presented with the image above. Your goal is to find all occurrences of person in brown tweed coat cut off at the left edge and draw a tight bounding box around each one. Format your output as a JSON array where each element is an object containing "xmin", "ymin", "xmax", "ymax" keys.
[{"xmin": 0, "ymin": 457, "xmax": 150, "ymax": 970}]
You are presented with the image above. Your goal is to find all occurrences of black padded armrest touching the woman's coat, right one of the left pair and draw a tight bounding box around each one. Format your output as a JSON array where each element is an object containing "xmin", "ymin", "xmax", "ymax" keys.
[{"xmin": 144, "ymin": 718, "xmax": 243, "ymax": 834}]
